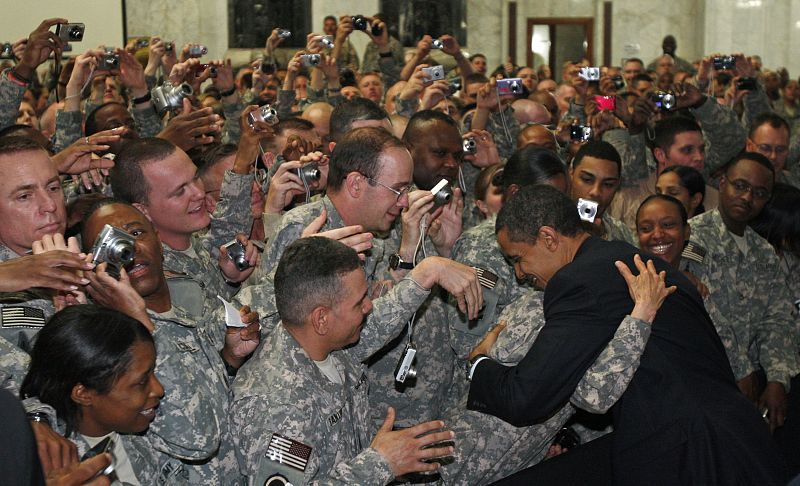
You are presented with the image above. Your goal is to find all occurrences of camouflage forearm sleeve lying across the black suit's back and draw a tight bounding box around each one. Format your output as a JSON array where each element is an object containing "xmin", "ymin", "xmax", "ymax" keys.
[{"xmin": 570, "ymin": 316, "xmax": 653, "ymax": 414}]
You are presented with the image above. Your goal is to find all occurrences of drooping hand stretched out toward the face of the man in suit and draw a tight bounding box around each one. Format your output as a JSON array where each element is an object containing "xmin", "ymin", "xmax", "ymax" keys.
[{"xmin": 412, "ymin": 255, "xmax": 483, "ymax": 321}]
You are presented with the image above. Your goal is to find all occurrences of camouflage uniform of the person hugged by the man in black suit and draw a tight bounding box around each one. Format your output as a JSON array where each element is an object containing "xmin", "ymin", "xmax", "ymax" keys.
[{"xmin": 432, "ymin": 292, "xmax": 651, "ymax": 484}]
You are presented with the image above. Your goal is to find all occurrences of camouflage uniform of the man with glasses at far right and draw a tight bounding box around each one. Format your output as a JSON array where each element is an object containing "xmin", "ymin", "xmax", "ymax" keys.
[{"xmin": 685, "ymin": 210, "xmax": 800, "ymax": 391}]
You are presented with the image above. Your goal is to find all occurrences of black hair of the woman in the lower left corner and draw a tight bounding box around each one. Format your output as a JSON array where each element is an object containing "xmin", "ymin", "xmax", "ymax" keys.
[{"xmin": 20, "ymin": 304, "xmax": 153, "ymax": 436}]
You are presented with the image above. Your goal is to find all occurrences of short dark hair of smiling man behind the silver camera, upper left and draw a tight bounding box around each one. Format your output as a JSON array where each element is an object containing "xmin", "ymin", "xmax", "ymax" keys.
[{"xmin": 110, "ymin": 138, "xmax": 178, "ymax": 203}]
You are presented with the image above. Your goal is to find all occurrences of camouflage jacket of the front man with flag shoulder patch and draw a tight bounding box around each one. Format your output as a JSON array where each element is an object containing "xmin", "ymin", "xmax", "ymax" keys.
[{"xmin": 230, "ymin": 325, "xmax": 394, "ymax": 485}]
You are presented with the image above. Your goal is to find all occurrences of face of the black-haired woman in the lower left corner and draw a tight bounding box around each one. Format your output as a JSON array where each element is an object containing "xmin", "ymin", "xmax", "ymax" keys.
[{"xmin": 77, "ymin": 341, "xmax": 164, "ymax": 437}]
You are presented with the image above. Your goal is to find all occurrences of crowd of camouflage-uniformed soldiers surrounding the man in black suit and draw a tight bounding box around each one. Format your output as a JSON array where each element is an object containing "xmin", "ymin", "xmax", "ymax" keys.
[{"xmin": 0, "ymin": 15, "xmax": 800, "ymax": 485}]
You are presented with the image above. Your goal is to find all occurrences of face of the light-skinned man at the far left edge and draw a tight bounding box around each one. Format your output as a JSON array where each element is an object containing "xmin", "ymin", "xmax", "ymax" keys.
[{"xmin": 0, "ymin": 149, "xmax": 67, "ymax": 255}]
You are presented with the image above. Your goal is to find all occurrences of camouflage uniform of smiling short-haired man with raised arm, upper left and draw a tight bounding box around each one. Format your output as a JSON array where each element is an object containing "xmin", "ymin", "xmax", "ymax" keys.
[{"xmin": 164, "ymin": 171, "xmax": 253, "ymax": 317}]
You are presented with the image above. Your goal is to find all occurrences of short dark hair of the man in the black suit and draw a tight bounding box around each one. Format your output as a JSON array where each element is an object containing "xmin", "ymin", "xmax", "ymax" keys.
[{"xmin": 495, "ymin": 184, "xmax": 583, "ymax": 243}]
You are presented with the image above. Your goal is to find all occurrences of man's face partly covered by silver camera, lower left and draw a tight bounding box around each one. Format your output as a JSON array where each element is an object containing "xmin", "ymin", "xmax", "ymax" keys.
[{"xmin": 82, "ymin": 204, "xmax": 166, "ymax": 297}]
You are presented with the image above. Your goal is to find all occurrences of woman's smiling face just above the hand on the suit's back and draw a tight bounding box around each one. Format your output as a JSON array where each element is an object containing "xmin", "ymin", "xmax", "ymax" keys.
[{"xmin": 636, "ymin": 199, "xmax": 690, "ymax": 268}]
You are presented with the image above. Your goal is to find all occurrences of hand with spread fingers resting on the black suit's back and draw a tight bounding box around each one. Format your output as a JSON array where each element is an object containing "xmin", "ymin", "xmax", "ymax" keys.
[{"xmin": 614, "ymin": 254, "xmax": 678, "ymax": 322}]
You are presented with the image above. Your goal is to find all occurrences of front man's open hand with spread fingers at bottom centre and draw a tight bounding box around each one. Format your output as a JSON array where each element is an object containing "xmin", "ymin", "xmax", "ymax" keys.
[{"xmin": 370, "ymin": 407, "xmax": 455, "ymax": 477}]
